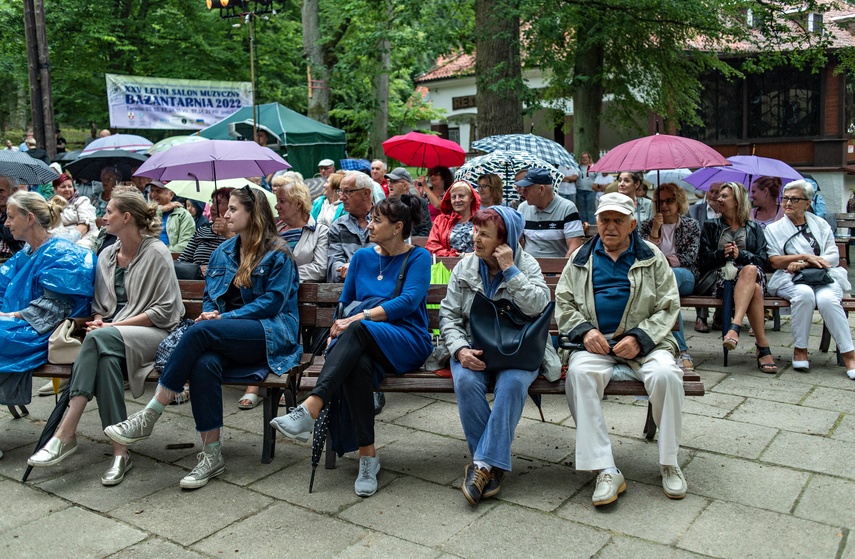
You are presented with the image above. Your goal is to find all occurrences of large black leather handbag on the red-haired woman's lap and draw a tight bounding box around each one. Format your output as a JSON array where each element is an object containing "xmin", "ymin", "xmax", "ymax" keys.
[{"xmin": 469, "ymin": 292, "xmax": 555, "ymax": 372}]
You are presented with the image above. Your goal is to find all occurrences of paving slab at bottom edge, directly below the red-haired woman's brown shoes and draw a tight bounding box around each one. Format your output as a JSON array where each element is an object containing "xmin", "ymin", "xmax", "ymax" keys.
[{"xmin": 443, "ymin": 505, "xmax": 609, "ymax": 559}]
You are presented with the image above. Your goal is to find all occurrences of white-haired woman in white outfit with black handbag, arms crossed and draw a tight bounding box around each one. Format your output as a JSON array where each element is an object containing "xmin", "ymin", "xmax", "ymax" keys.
[{"xmin": 766, "ymin": 180, "xmax": 855, "ymax": 380}]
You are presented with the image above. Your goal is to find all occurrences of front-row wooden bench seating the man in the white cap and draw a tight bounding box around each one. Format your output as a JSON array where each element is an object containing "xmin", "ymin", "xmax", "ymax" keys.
[{"xmin": 297, "ymin": 284, "xmax": 704, "ymax": 468}]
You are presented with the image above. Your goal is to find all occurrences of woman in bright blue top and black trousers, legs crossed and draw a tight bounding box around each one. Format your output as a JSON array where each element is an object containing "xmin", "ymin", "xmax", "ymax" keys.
[{"xmin": 270, "ymin": 194, "xmax": 433, "ymax": 497}]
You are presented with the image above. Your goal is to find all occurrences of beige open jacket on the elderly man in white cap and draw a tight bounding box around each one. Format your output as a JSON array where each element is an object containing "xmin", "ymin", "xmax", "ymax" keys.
[{"xmin": 555, "ymin": 232, "xmax": 680, "ymax": 369}]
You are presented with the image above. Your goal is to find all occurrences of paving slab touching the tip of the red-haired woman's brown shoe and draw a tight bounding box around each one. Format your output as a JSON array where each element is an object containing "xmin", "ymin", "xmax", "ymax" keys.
[{"xmin": 338, "ymin": 477, "xmax": 495, "ymax": 547}]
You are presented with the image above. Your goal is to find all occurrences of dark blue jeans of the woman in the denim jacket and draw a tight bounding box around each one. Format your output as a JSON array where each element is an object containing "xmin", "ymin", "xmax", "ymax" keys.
[{"xmin": 159, "ymin": 318, "xmax": 268, "ymax": 433}]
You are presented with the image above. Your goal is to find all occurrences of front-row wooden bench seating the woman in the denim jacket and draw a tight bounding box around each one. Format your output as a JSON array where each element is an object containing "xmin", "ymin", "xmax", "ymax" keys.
[{"xmin": 19, "ymin": 280, "xmax": 334, "ymax": 464}]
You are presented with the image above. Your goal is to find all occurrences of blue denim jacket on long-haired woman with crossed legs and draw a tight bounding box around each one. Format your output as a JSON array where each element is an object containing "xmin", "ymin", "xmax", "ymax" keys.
[{"xmin": 202, "ymin": 237, "xmax": 302, "ymax": 376}]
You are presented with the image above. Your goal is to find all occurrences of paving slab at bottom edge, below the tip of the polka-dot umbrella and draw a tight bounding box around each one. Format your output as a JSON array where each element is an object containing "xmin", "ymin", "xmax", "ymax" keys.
[{"xmin": 193, "ymin": 503, "xmax": 366, "ymax": 559}]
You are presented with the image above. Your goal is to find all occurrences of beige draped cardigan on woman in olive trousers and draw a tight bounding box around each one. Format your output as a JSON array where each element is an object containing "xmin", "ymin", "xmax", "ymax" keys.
[{"xmin": 92, "ymin": 237, "xmax": 184, "ymax": 398}]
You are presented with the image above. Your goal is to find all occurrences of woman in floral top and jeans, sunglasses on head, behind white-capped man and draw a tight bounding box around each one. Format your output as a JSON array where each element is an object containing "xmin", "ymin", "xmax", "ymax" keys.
[{"xmin": 639, "ymin": 182, "xmax": 701, "ymax": 371}]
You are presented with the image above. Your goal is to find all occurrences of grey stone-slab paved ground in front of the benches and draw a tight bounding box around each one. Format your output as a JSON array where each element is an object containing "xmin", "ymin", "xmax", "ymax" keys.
[{"xmin": 0, "ymin": 311, "xmax": 855, "ymax": 559}]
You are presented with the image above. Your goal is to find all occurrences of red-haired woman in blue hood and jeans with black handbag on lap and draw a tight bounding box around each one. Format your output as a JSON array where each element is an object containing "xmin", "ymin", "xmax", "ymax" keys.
[{"xmin": 439, "ymin": 206, "xmax": 561, "ymax": 505}]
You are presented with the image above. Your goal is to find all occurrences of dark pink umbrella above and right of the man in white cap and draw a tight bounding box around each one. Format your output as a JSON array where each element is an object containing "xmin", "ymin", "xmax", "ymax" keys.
[{"xmin": 590, "ymin": 134, "xmax": 731, "ymax": 173}]
